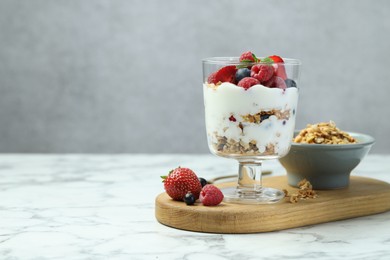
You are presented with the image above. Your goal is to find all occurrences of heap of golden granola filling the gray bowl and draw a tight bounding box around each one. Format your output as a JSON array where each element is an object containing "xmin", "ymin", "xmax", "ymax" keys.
[{"xmin": 293, "ymin": 121, "xmax": 357, "ymax": 144}]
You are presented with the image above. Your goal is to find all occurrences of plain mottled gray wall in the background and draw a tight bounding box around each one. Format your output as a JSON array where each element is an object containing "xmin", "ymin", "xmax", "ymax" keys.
[{"xmin": 0, "ymin": 0, "xmax": 390, "ymax": 153}]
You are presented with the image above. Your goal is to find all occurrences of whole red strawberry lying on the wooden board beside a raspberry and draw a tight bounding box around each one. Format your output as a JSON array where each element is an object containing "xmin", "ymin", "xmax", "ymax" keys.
[{"xmin": 161, "ymin": 167, "xmax": 202, "ymax": 201}]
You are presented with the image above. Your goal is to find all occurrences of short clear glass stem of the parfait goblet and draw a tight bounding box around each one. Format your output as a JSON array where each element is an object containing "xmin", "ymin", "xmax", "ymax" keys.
[{"xmin": 237, "ymin": 161, "xmax": 262, "ymax": 196}]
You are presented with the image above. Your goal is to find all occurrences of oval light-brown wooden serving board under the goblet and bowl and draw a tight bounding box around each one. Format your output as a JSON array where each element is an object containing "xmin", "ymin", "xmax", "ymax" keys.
[{"xmin": 155, "ymin": 176, "xmax": 390, "ymax": 233}]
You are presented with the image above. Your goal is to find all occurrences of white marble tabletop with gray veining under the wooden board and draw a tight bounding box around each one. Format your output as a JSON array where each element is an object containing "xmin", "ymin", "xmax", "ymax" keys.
[{"xmin": 0, "ymin": 154, "xmax": 390, "ymax": 260}]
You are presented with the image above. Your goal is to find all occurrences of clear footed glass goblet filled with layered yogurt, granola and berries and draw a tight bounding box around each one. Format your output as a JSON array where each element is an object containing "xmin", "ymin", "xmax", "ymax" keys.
[{"xmin": 202, "ymin": 57, "xmax": 301, "ymax": 204}]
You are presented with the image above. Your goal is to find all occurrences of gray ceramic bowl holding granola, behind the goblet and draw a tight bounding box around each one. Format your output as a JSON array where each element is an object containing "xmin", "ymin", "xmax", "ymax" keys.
[{"xmin": 279, "ymin": 132, "xmax": 375, "ymax": 189}]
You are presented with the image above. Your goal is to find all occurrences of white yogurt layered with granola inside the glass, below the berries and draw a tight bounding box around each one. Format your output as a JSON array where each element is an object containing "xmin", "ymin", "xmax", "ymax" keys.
[{"xmin": 203, "ymin": 82, "xmax": 298, "ymax": 156}]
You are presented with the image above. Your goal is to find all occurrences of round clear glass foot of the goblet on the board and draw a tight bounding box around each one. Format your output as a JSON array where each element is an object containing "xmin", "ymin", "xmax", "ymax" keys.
[{"xmin": 221, "ymin": 187, "xmax": 285, "ymax": 204}]
